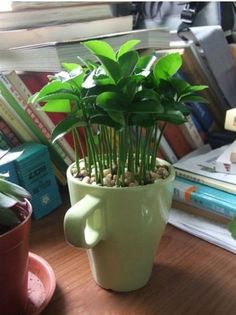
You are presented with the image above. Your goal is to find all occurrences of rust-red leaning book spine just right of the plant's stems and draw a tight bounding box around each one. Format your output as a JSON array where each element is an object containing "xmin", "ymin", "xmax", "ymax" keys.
[{"xmin": 161, "ymin": 124, "xmax": 192, "ymax": 158}]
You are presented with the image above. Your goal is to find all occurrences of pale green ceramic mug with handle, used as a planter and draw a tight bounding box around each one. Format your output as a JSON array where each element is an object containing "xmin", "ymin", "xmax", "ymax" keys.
[{"xmin": 64, "ymin": 160, "xmax": 175, "ymax": 291}]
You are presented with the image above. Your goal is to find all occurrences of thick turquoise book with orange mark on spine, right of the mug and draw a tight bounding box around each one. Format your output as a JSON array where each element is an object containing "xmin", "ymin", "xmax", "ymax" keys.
[{"xmin": 173, "ymin": 176, "xmax": 236, "ymax": 219}]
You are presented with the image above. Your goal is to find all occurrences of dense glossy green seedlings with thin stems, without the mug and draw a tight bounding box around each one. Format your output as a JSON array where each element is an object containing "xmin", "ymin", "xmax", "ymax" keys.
[{"xmin": 29, "ymin": 40, "xmax": 206, "ymax": 186}]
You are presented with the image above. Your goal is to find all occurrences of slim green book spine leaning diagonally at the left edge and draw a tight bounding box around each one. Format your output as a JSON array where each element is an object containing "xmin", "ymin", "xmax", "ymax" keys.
[{"xmin": 0, "ymin": 74, "xmax": 67, "ymax": 173}]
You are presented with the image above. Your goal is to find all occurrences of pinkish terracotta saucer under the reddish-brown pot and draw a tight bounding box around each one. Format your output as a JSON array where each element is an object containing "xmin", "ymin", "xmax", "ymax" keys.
[{"xmin": 25, "ymin": 253, "xmax": 56, "ymax": 315}]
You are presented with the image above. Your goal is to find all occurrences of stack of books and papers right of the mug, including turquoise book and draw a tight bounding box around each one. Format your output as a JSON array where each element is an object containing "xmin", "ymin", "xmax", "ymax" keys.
[{"xmin": 173, "ymin": 145, "xmax": 236, "ymax": 224}]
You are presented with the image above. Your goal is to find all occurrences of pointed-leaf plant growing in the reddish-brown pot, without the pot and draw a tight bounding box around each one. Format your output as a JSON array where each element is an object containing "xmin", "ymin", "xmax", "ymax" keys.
[{"xmin": 0, "ymin": 150, "xmax": 30, "ymax": 234}]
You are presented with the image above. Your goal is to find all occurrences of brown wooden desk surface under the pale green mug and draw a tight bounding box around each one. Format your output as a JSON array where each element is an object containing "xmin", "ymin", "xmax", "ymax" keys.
[{"xmin": 30, "ymin": 193, "xmax": 236, "ymax": 315}]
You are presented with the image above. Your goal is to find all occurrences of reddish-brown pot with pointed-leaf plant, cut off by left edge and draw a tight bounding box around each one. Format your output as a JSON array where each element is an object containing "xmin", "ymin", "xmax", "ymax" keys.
[{"xmin": 0, "ymin": 151, "xmax": 32, "ymax": 315}]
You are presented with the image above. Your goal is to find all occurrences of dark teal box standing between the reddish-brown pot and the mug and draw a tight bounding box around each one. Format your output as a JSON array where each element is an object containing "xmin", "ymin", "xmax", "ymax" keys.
[{"xmin": 14, "ymin": 143, "xmax": 61, "ymax": 219}]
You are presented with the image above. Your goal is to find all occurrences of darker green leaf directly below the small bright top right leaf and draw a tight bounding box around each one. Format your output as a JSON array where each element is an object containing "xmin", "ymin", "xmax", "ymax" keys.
[{"xmin": 118, "ymin": 51, "xmax": 138, "ymax": 77}]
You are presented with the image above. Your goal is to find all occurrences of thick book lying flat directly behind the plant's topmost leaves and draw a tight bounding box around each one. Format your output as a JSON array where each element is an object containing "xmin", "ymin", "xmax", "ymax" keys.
[{"xmin": 0, "ymin": 28, "xmax": 171, "ymax": 72}]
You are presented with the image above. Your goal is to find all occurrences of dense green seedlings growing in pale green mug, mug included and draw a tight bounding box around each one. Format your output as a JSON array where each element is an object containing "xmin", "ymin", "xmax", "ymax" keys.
[{"xmin": 30, "ymin": 40, "xmax": 205, "ymax": 291}]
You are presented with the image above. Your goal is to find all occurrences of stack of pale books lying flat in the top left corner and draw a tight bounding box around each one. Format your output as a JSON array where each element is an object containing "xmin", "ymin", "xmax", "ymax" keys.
[{"xmin": 0, "ymin": 0, "xmax": 133, "ymax": 50}]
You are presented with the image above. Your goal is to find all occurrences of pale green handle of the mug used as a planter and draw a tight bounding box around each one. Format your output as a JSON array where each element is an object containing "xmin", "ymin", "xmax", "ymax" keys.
[{"xmin": 64, "ymin": 195, "xmax": 105, "ymax": 248}]
